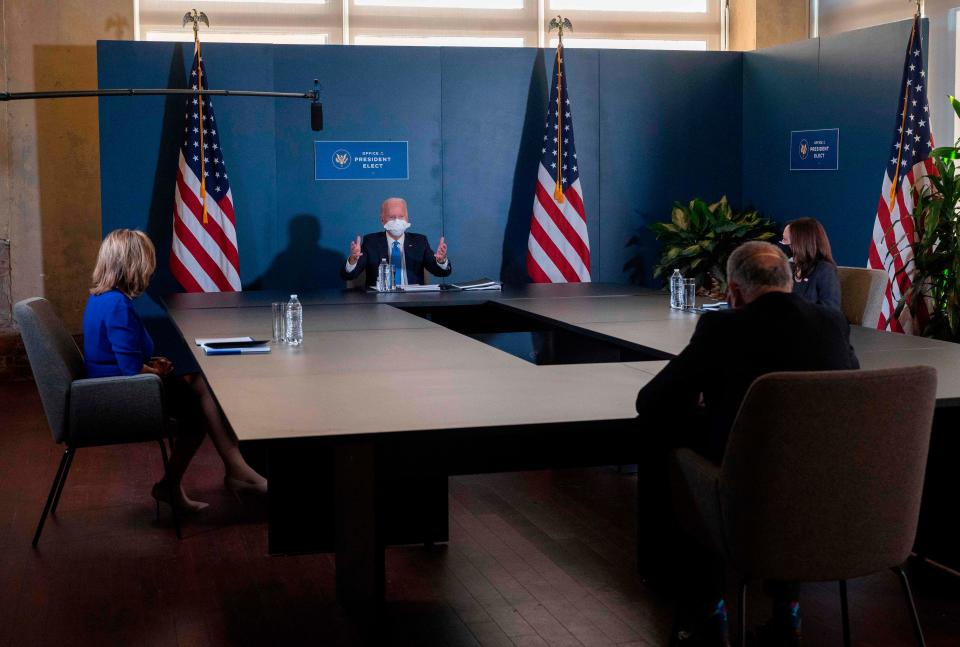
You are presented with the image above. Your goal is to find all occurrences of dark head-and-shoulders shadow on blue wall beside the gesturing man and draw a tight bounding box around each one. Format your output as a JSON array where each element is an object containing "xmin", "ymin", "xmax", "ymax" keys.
[{"xmin": 244, "ymin": 213, "xmax": 347, "ymax": 293}]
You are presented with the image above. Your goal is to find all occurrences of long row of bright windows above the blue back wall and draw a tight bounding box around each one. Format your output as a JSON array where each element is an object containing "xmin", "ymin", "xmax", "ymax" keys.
[{"xmin": 134, "ymin": 0, "xmax": 722, "ymax": 50}]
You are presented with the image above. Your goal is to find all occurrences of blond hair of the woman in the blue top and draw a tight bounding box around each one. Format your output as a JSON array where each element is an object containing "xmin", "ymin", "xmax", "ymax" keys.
[{"xmin": 90, "ymin": 229, "xmax": 157, "ymax": 298}]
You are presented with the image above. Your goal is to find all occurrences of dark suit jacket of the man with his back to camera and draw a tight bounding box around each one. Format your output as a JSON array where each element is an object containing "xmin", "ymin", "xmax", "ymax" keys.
[{"xmin": 637, "ymin": 292, "xmax": 860, "ymax": 462}]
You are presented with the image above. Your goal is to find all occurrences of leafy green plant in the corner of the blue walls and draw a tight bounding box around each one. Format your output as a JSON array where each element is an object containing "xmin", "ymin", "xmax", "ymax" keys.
[{"xmin": 650, "ymin": 196, "xmax": 777, "ymax": 296}]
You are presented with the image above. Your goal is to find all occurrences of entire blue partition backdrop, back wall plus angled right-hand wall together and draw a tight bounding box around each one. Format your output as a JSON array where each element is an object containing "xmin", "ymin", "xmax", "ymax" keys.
[{"xmin": 98, "ymin": 17, "xmax": 910, "ymax": 293}]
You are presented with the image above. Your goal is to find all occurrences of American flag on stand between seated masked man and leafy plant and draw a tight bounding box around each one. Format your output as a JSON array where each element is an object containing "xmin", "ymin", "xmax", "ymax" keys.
[{"xmin": 527, "ymin": 44, "xmax": 590, "ymax": 283}]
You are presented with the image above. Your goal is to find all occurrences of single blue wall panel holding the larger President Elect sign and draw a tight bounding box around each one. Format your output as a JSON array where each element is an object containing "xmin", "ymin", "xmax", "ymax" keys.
[{"xmin": 270, "ymin": 46, "xmax": 442, "ymax": 290}]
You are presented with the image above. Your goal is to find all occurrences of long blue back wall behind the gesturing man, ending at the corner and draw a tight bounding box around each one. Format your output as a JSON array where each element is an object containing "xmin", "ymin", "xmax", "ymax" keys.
[{"xmin": 98, "ymin": 41, "xmax": 742, "ymax": 292}]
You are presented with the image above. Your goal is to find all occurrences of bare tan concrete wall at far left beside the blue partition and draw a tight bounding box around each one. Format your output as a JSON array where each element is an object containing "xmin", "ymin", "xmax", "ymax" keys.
[{"xmin": 0, "ymin": 0, "xmax": 133, "ymax": 380}]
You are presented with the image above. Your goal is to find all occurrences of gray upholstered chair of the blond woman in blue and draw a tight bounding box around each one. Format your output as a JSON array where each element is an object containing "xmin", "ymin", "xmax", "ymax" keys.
[{"xmin": 13, "ymin": 298, "xmax": 180, "ymax": 547}]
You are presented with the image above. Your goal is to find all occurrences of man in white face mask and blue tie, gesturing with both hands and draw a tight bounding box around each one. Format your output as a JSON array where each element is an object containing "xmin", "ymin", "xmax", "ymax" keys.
[{"xmin": 340, "ymin": 198, "xmax": 452, "ymax": 287}]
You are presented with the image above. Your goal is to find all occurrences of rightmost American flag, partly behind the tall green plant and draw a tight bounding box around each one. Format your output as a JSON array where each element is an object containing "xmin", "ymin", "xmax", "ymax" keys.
[{"xmin": 869, "ymin": 16, "xmax": 936, "ymax": 334}]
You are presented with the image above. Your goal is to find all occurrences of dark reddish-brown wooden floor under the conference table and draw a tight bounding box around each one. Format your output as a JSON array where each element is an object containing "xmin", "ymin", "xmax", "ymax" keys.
[{"xmin": 0, "ymin": 384, "xmax": 960, "ymax": 647}]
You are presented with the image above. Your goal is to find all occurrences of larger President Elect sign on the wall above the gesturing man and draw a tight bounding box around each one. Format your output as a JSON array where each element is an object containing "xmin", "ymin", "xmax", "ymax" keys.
[{"xmin": 313, "ymin": 141, "xmax": 410, "ymax": 180}]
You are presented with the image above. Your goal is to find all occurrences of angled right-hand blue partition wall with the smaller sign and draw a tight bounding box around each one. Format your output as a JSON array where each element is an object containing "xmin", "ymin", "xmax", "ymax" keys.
[{"xmin": 743, "ymin": 21, "xmax": 916, "ymax": 267}]
